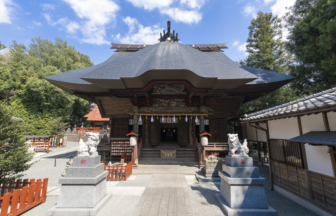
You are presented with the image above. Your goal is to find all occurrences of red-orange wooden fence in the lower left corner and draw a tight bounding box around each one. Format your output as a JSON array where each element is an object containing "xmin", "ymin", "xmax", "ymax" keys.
[{"xmin": 0, "ymin": 178, "xmax": 48, "ymax": 216}]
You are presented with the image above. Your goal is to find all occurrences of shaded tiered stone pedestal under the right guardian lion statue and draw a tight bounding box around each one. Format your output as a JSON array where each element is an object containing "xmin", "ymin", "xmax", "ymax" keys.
[{"xmin": 216, "ymin": 155, "xmax": 278, "ymax": 216}]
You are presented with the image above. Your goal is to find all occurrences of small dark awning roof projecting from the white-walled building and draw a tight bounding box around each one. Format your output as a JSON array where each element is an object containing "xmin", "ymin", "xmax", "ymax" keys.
[{"xmin": 288, "ymin": 131, "xmax": 336, "ymax": 145}]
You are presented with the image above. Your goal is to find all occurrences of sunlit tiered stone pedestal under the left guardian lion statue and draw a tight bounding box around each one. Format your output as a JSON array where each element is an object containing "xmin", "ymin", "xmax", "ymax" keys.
[{"xmin": 47, "ymin": 155, "xmax": 111, "ymax": 216}]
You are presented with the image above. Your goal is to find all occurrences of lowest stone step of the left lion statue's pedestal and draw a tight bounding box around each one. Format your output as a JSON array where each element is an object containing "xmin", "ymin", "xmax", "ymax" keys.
[{"xmin": 47, "ymin": 194, "xmax": 112, "ymax": 216}]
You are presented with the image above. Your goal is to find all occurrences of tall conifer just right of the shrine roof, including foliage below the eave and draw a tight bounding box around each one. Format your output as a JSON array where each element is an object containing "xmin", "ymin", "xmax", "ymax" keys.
[{"xmin": 239, "ymin": 11, "xmax": 297, "ymax": 113}]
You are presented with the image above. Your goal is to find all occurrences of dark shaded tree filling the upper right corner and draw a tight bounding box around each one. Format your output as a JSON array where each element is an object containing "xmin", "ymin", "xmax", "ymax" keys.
[{"xmin": 285, "ymin": 0, "xmax": 336, "ymax": 96}]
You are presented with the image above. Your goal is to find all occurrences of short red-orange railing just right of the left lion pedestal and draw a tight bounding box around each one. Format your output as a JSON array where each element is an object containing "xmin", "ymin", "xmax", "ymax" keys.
[{"xmin": 102, "ymin": 161, "xmax": 132, "ymax": 181}]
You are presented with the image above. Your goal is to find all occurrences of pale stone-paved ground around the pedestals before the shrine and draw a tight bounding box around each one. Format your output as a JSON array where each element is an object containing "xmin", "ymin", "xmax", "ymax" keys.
[{"xmin": 22, "ymin": 144, "xmax": 316, "ymax": 216}]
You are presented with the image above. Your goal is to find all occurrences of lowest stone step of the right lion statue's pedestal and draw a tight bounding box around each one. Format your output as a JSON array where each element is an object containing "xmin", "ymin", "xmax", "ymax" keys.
[{"xmin": 215, "ymin": 193, "xmax": 278, "ymax": 216}]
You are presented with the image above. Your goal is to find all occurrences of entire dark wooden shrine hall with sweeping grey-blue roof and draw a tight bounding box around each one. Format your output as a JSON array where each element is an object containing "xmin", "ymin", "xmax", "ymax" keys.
[{"xmin": 45, "ymin": 22, "xmax": 293, "ymax": 164}]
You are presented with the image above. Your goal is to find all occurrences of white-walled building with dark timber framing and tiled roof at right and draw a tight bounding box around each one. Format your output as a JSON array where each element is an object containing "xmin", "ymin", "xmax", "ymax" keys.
[{"xmin": 240, "ymin": 88, "xmax": 336, "ymax": 215}]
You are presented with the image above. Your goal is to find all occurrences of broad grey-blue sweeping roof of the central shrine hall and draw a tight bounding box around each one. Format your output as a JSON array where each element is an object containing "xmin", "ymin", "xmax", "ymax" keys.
[{"xmin": 46, "ymin": 42, "xmax": 293, "ymax": 85}]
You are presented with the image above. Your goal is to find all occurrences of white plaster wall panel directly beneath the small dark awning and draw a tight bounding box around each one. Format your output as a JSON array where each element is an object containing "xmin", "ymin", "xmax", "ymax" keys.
[{"xmin": 305, "ymin": 144, "xmax": 334, "ymax": 177}]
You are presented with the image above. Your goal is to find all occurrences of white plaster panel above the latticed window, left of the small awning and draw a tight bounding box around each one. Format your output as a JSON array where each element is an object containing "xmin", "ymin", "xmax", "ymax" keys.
[{"xmin": 268, "ymin": 117, "xmax": 300, "ymax": 139}]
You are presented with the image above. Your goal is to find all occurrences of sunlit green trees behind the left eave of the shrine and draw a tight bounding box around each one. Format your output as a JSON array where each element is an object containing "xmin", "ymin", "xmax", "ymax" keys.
[{"xmin": 0, "ymin": 38, "xmax": 93, "ymax": 135}]
